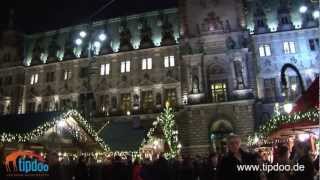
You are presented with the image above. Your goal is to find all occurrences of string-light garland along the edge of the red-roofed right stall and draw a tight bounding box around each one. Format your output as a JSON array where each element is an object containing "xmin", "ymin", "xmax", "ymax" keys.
[{"xmin": 248, "ymin": 110, "xmax": 319, "ymax": 145}]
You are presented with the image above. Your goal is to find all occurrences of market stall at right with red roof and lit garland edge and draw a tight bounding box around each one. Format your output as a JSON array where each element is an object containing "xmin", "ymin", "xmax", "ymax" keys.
[{"xmin": 249, "ymin": 77, "xmax": 320, "ymax": 160}]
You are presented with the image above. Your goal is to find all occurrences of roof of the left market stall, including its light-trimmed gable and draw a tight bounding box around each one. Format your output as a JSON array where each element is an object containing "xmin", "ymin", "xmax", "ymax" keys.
[{"xmin": 0, "ymin": 110, "xmax": 109, "ymax": 151}]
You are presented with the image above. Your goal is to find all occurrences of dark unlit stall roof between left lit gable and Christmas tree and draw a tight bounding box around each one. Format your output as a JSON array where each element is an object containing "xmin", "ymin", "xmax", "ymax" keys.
[{"xmin": 99, "ymin": 121, "xmax": 148, "ymax": 151}]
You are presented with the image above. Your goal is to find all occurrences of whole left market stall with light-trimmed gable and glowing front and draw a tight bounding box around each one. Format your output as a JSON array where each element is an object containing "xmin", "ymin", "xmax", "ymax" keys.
[{"xmin": 0, "ymin": 110, "xmax": 109, "ymax": 154}]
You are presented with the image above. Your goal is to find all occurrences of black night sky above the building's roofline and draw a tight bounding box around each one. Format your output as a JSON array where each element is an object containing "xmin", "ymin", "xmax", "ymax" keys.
[{"xmin": 0, "ymin": 0, "xmax": 177, "ymax": 33}]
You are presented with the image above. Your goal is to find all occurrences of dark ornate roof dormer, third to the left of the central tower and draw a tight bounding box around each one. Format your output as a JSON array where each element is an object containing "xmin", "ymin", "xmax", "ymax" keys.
[{"xmin": 120, "ymin": 20, "xmax": 133, "ymax": 51}]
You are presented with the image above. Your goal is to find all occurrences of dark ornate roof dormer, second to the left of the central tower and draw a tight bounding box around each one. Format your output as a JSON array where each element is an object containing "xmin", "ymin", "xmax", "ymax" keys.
[{"xmin": 139, "ymin": 18, "xmax": 154, "ymax": 48}]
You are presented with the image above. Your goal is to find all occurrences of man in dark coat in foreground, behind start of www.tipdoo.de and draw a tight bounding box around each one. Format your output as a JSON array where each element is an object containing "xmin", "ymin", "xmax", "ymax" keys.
[{"xmin": 218, "ymin": 134, "xmax": 259, "ymax": 180}]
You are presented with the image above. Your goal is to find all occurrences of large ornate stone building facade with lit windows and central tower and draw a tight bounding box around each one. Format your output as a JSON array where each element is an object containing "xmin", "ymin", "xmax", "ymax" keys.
[{"xmin": 0, "ymin": 0, "xmax": 320, "ymax": 154}]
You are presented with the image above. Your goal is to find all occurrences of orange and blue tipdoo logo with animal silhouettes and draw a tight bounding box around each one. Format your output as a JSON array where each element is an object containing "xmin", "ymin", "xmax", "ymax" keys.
[{"xmin": 4, "ymin": 150, "xmax": 49, "ymax": 176}]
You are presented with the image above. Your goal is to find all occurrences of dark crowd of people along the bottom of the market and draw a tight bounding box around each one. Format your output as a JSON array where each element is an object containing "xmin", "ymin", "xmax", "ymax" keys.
[{"xmin": 0, "ymin": 135, "xmax": 319, "ymax": 180}]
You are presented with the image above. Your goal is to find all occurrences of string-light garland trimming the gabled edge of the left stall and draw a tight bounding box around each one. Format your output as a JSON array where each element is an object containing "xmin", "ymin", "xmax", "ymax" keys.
[{"xmin": 0, "ymin": 110, "xmax": 110, "ymax": 151}]
